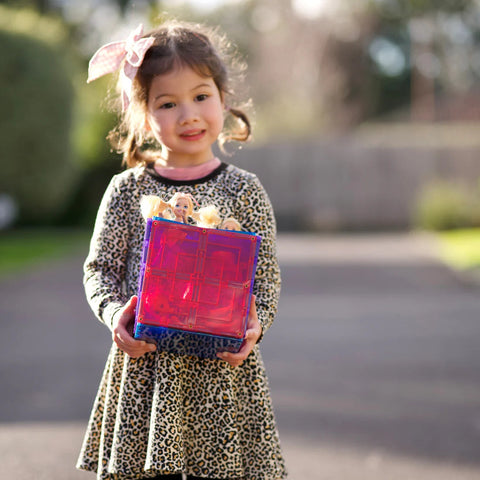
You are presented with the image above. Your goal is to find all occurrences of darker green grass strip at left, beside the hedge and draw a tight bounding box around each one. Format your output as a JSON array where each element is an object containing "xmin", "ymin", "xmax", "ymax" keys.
[{"xmin": 0, "ymin": 228, "xmax": 91, "ymax": 276}]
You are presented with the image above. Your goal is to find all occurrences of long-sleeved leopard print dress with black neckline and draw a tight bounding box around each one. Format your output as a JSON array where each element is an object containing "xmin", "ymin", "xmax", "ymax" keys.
[{"xmin": 77, "ymin": 163, "xmax": 286, "ymax": 480}]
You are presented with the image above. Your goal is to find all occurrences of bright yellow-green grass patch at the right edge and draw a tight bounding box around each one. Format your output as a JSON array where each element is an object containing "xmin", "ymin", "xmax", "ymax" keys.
[{"xmin": 438, "ymin": 228, "xmax": 480, "ymax": 270}]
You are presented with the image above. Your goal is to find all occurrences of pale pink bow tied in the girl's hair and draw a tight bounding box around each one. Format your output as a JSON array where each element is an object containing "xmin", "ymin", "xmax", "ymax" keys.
[{"xmin": 87, "ymin": 24, "xmax": 155, "ymax": 111}]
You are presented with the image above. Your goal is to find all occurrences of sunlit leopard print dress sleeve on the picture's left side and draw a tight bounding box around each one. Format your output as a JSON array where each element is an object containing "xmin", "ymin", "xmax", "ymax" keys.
[{"xmin": 83, "ymin": 177, "xmax": 130, "ymax": 329}]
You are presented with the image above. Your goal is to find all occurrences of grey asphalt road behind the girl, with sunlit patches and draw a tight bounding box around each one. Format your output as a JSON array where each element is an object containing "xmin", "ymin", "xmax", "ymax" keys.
[{"xmin": 0, "ymin": 236, "xmax": 480, "ymax": 480}]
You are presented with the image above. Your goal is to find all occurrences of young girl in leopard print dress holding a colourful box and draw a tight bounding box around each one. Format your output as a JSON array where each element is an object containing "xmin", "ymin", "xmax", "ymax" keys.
[{"xmin": 77, "ymin": 23, "xmax": 286, "ymax": 480}]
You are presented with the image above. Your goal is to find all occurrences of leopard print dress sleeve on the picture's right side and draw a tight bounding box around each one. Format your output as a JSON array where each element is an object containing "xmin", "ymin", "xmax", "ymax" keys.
[{"xmin": 236, "ymin": 175, "xmax": 281, "ymax": 333}]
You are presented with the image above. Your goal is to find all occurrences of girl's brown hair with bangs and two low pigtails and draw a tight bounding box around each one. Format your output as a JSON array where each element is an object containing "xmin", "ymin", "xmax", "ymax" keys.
[{"xmin": 108, "ymin": 21, "xmax": 251, "ymax": 167}]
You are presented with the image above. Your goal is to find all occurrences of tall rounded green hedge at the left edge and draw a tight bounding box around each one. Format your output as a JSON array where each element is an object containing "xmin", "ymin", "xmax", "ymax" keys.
[{"xmin": 0, "ymin": 7, "xmax": 76, "ymax": 224}]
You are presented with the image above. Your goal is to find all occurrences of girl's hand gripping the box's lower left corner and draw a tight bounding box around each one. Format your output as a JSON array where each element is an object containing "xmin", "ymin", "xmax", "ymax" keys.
[{"xmin": 112, "ymin": 295, "xmax": 156, "ymax": 358}]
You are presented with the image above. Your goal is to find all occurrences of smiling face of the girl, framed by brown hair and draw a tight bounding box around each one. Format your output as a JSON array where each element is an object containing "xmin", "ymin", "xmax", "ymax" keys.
[{"xmin": 145, "ymin": 67, "xmax": 224, "ymax": 166}]
